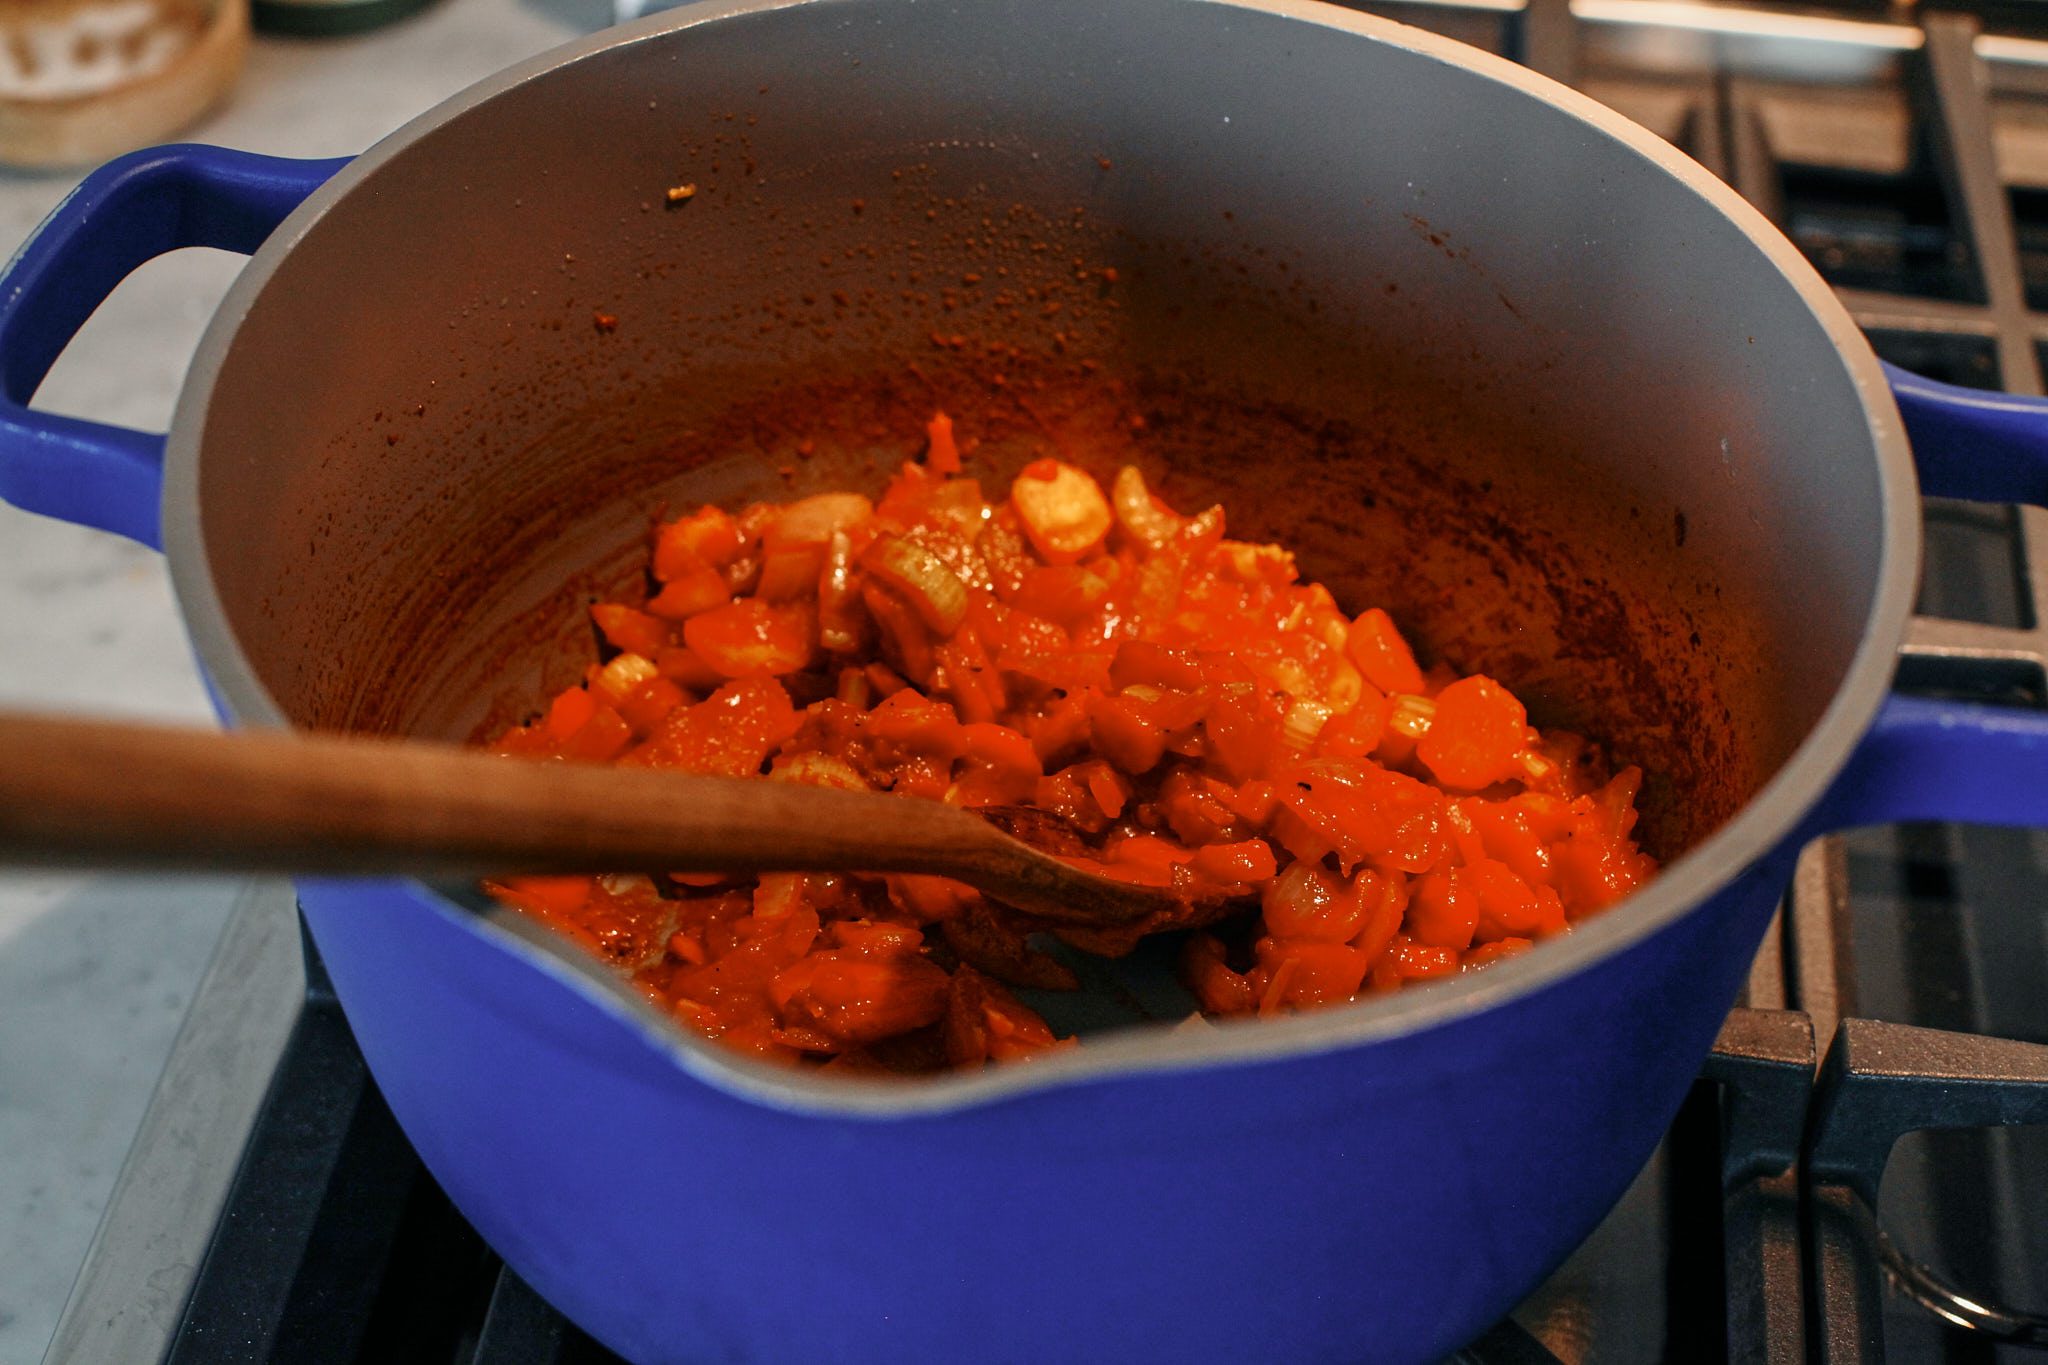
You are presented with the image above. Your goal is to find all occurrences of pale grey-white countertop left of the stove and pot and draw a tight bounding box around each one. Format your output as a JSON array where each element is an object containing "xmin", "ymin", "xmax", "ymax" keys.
[{"xmin": 0, "ymin": 0, "xmax": 610, "ymax": 1365}]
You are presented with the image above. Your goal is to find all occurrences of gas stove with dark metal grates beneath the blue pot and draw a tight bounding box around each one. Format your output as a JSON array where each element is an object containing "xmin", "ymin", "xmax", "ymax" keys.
[{"xmin": 45, "ymin": 0, "xmax": 2048, "ymax": 1365}]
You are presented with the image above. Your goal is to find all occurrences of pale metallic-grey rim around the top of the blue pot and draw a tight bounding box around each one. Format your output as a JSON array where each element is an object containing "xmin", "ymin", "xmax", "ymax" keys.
[{"xmin": 164, "ymin": 0, "xmax": 1921, "ymax": 1119}]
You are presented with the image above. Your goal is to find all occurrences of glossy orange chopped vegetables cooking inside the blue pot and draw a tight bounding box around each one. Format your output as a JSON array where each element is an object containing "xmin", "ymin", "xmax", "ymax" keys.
[{"xmin": 492, "ymin": 415, "xmax": 1657, "ymax": 1072}]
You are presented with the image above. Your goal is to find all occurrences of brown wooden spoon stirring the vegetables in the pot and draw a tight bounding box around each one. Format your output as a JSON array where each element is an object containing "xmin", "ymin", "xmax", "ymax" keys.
[{"xmin": 0, "ymin": 716, "xmax": 1188, "ymax": 925}]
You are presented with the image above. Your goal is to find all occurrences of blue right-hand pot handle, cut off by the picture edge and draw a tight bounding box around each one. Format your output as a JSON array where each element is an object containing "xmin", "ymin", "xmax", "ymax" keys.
[{"xmin": 1810, "ymin": 364, "xmax": 2048, "ymax": 833}]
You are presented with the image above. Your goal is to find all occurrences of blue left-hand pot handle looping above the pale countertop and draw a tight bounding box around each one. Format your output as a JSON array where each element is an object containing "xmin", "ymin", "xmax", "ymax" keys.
[{"xmin": 0, "ymin": 145, "xmax": 350, "ymax": 548}]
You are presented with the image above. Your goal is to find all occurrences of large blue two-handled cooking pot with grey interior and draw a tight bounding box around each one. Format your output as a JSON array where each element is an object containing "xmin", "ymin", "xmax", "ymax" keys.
[{"xmin": 0, "ymin": 0, "xmax": 2048, "ymax": 1365}]
